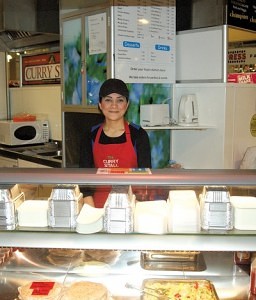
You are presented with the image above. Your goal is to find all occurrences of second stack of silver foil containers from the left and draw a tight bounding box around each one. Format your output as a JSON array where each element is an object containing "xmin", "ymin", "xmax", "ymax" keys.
[{"xmin": 48, "ymin": 185, "xmax": 83, "ymax": 228}]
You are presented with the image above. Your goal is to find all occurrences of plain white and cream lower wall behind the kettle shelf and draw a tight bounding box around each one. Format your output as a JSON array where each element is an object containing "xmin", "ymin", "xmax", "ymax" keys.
[{"xmin": 171, "ymin": 83, "xmax": 256, "ymax": 169}]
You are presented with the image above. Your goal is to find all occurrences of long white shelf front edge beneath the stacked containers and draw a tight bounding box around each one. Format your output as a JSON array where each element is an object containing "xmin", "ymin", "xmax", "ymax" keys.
[{"xmin": 0, "ymin": 230, "xmax": 256, "ymax": 251}]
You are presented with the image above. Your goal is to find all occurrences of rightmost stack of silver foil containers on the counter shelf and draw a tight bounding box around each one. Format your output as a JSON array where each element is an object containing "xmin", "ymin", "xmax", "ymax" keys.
[{"xmin": 200, "ymin": 186, "xmax": 233, "ymax": 230}]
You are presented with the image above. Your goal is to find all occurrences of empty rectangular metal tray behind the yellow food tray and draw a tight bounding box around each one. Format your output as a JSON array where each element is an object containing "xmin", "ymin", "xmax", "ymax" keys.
[{"xmin": 140, "ymin": 251, "xmax": 206, "ymax": 272}]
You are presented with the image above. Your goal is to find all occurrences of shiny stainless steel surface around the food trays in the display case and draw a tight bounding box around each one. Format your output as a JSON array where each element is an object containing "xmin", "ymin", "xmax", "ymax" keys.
[{"xmin": 0, "ymin": 249, "xmax": 249, "ymax": 300}]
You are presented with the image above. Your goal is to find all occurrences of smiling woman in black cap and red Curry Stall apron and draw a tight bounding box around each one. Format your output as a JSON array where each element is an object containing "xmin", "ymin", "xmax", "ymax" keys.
[{"xmin": 80, "ymin": 78, "xmax": 151, "ymax": 207}]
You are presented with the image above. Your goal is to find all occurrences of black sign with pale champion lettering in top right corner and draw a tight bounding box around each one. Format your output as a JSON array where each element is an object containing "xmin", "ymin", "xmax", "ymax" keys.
[{"xmin": 228, "ymin": 0, "xmax": 256, "ymax": 31}]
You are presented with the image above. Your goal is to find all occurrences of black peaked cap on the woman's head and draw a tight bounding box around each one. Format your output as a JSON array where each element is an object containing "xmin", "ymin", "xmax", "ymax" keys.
[{"xmin": 99, "ymin": 78, "xmax": 129, "ymax": 100}]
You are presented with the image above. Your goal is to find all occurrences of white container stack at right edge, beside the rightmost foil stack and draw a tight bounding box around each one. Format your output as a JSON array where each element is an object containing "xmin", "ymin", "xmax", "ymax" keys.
[{"xmin": 230, "ymin": 196, "xmax": 256, "ymax": 230}]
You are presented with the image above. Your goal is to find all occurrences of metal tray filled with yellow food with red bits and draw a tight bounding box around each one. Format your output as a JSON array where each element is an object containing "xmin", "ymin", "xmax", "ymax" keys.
[{"xmin": 142, "ymin": 278, "xmax": 219, "ymax": 300}]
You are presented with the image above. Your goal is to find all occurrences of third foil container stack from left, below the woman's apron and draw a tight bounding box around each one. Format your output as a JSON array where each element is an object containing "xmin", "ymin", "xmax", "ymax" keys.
[{"xmin": 104, "ymin": 186, "xmax": 135, "ymax": 233}]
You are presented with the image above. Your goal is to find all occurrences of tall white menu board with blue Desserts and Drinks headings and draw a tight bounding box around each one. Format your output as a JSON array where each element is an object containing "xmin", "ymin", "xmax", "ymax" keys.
[{"xmin": 114, "ymin": 0, "xmax": 176, "ymax": 83}]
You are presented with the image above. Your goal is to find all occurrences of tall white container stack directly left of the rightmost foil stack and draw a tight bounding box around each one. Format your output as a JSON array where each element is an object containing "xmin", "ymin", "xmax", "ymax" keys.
[{"xmin": 167, "ymin": 190, "xmax": 200, "ymax": 232}]
